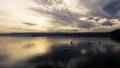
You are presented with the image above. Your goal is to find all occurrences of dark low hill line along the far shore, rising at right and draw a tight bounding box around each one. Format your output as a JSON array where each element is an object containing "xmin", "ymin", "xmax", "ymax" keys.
[{"xmin": 0, "ymin": 29, "xmax": 120, "ymax": 37}]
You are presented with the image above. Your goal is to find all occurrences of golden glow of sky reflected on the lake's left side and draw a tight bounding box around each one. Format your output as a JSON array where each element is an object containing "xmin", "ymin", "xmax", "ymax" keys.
[{"xmin": 0, "ymin": 37, "xmax": 50, "ymax": 66}]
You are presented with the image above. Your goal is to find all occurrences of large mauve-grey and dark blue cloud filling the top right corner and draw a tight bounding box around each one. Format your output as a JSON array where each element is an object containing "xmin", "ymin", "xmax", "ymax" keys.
[{"xmin": 78, "ymin": 0, "xmax": 120, "ymax": 18}]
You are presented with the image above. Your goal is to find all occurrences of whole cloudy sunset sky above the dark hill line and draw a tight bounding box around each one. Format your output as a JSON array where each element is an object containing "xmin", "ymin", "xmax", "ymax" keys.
[{"xmin": 0, "ymin": 0, "xmax": 120, "ymax": 33}]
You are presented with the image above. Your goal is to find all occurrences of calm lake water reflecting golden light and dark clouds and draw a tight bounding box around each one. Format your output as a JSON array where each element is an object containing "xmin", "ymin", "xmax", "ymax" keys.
[{"xmin": 0, "ymin": 37, "xmax": 120, "ymax": 68}]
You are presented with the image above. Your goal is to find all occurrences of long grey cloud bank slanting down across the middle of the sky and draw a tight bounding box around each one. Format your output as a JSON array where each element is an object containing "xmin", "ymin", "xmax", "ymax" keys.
[{"xmin": 31, "ymin": 0, "xmax": 94, "ymax": 29}]
